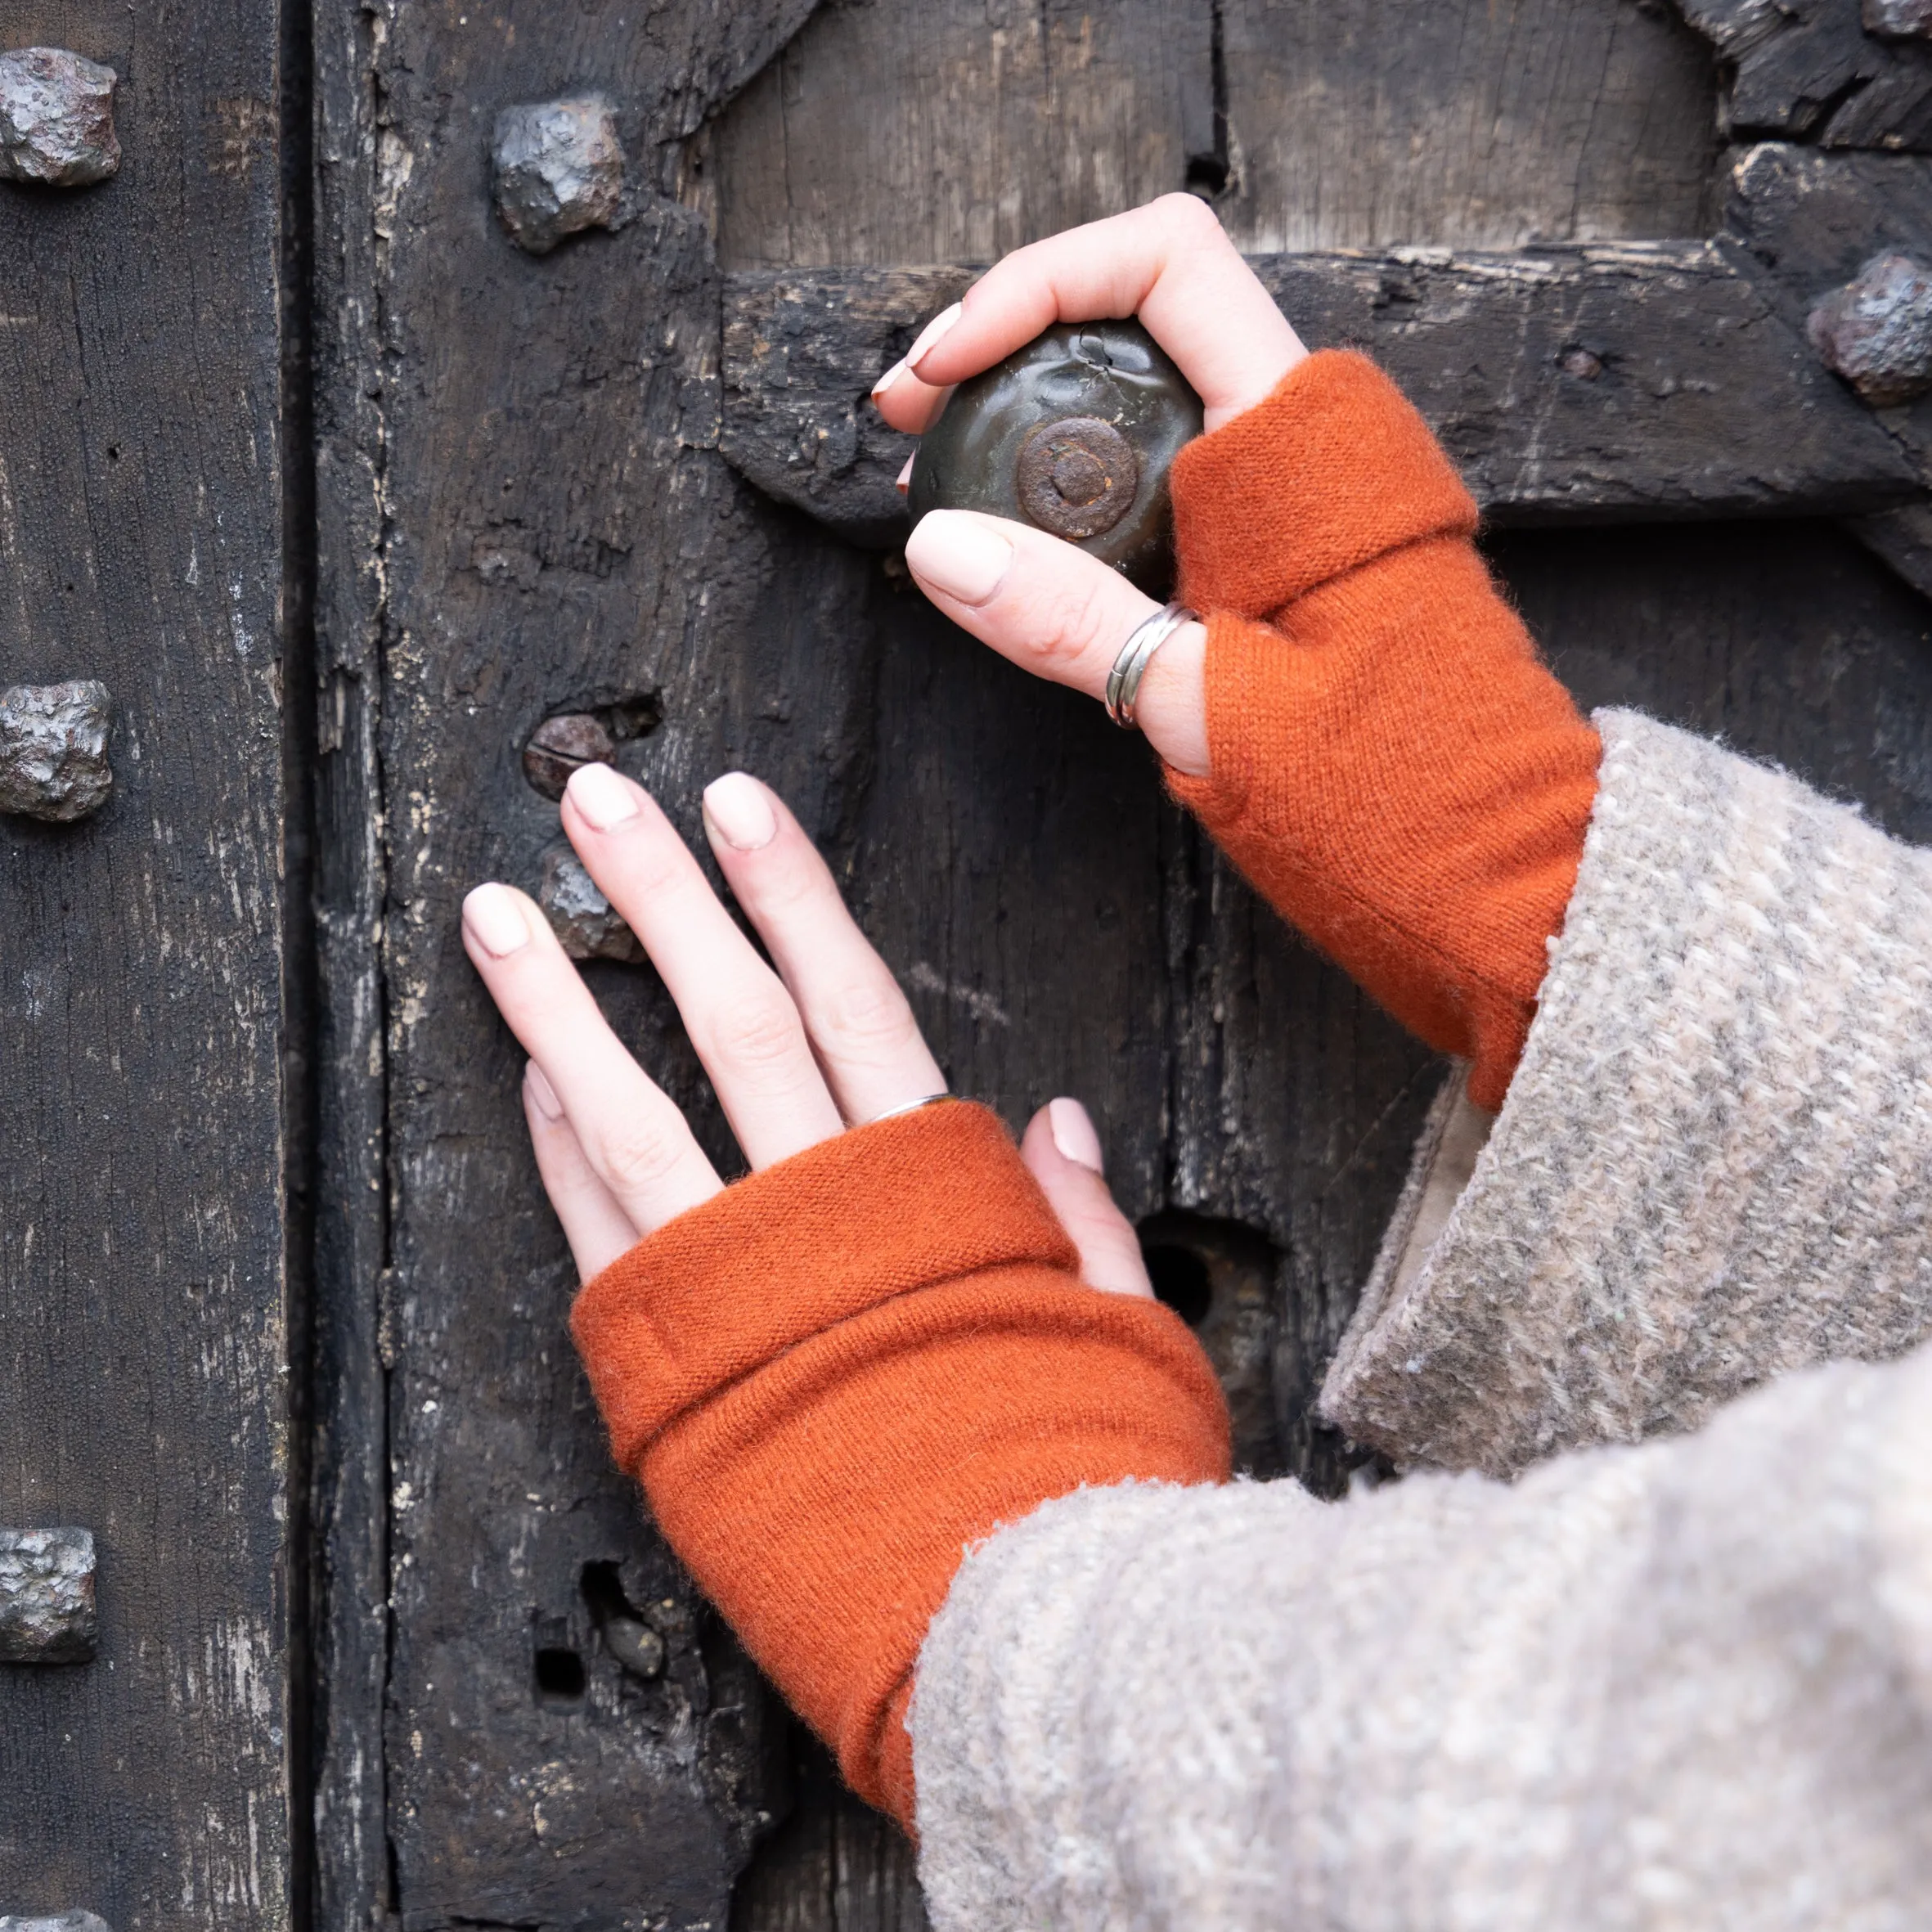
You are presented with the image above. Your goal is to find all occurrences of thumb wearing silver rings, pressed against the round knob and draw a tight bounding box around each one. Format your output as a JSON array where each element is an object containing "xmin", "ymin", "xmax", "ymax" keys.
[{"xmin": 906, "ymin": 510, "xmax": 1207, "ymax": 779}]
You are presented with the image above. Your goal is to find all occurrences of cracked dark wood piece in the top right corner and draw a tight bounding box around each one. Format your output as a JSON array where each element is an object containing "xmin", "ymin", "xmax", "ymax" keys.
[{"xmin": 1677, "ymin": 0, "xmax": 1932, "ymax": 153}]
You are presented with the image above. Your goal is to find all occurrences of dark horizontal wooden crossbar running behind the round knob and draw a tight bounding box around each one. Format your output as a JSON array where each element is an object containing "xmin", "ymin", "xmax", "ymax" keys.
[{"xmin": 722, "ymin": 244, "xmax": 1916, "ymax": 545}]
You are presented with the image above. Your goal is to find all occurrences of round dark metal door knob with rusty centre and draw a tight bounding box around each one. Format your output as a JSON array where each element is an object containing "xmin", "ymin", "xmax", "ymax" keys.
[{"xmin": 910, "ymin": 322, "xmax": 1202, "ymax": 595}]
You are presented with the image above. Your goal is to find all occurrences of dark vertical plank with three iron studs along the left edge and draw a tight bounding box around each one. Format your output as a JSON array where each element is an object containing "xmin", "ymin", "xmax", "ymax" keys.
[{"xmin": 0, "ymin": 0, "xmax": 290, "ymax": 1932}]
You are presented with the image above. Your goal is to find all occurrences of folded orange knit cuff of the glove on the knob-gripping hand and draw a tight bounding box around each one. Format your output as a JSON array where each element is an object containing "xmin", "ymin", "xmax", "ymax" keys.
[{"xmin": 1173, "ymin": 350, "xmax": 1476, "ymax": 618}]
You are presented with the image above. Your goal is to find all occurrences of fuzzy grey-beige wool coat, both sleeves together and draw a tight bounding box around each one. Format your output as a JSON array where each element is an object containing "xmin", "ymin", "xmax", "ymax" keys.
[{"xmin": 910, "ymin": 713, "xmax": 1932, "ymax": 1932}]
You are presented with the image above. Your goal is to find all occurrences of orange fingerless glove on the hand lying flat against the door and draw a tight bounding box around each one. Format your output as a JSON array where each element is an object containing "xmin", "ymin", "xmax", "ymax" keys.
[{"xmin": 572, "ymin": 1103, "xmax": 1229, "ymax": 1827}]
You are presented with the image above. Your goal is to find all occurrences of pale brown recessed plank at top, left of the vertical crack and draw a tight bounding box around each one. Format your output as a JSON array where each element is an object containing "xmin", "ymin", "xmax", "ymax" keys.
[{"xmin": 688, "ymin": 0, "xmax": 1213, "ymax": 267}]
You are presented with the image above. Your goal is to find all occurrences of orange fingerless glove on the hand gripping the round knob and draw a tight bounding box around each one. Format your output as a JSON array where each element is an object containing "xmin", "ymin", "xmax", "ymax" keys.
[{"xmin": 1169, "ymin": 350, "xmax": 1602, "ymax": 1109}]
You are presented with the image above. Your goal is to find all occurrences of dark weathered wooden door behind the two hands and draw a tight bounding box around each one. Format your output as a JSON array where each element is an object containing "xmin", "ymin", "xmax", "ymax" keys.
[{"xmin": 15, "ymin": 0, "xmax": 1932, "ymax": 1932}]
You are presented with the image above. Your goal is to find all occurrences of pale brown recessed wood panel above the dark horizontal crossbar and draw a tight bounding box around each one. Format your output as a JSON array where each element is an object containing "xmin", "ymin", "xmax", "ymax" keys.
[{"xmin": 692, "ymin": 0, "xmax": 1718, "ymax": 268}]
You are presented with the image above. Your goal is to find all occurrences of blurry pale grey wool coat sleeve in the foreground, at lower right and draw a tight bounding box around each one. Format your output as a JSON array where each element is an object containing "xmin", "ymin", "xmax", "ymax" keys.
[{"xmin": 912, "ymin": 1352, "xmax": 1932, "ymax": 1932}]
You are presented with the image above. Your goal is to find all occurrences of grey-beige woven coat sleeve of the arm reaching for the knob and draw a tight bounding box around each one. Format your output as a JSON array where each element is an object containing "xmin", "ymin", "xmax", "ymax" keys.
[{"xmin": 1322, "ymin": 711, "xmax": 1932, "ymax": 1474}]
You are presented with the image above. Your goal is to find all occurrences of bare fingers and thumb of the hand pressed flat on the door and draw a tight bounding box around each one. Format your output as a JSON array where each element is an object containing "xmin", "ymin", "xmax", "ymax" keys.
[{"xmin": 464, "ymin": 765, "xmax": 1152, "ymax": 1295}]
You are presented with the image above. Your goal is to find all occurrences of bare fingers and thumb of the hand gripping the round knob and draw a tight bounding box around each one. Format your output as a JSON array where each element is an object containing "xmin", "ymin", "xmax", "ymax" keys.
[{"xmin": 874, "ymin": 195, "xmax": 1308, "ymax": 777}]
